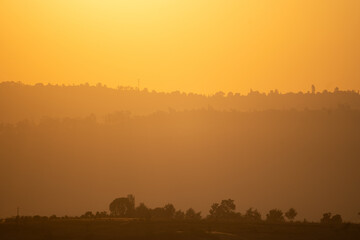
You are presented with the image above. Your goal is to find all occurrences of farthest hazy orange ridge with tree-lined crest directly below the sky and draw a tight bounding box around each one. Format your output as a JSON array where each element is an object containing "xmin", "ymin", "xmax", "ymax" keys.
[{"xmin": 0, "ymin": 82, "xmax": 360, "ymax": 123}]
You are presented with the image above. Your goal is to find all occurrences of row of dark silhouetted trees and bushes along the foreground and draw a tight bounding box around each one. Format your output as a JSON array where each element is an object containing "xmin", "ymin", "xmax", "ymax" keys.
[{"xmin": 5, "ymin": 195, "xmax": 350, "ymax": 225}]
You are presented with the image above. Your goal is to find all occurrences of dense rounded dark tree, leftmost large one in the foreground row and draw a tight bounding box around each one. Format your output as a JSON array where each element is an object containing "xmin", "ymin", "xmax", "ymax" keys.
[{"xmin": 109, "ymin": 194, "xmax": 135, "ymax": 217}]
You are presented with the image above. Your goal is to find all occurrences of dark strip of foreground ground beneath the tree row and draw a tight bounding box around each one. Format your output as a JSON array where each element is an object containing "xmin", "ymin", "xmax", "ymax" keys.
[{"xmin": 0, "ymin": 220, "xmax": 360, "ymax": 240}]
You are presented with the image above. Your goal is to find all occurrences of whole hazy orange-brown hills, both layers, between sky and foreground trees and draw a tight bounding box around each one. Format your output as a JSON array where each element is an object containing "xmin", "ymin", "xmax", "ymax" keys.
[{"xmin": 0, "ymin": 82, "xmax": 360, "ymax": 221}]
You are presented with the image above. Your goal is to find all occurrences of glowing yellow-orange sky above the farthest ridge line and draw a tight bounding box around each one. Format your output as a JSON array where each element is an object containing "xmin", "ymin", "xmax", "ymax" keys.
[{"xmin": 0, "ymin": 0, "xmax": 360, "ymax": 93}]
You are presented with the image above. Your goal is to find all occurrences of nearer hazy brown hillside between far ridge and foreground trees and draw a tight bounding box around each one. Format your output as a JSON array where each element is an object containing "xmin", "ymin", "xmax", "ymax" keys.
[{"xmin": 0, "ymin": 108, "xmax": 360, "ymax": 221}]
